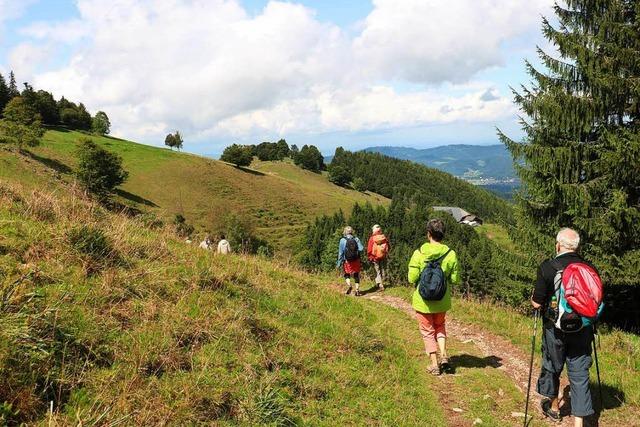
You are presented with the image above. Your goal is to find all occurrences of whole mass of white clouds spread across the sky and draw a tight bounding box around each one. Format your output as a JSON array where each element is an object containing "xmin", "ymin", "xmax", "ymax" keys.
[{"xmin": 23, "ymin": 0, "xmax": 548, "ymax": 147}]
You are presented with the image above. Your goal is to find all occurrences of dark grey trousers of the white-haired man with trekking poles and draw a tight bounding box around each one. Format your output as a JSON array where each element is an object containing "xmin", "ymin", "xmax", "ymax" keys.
[{"xmin": 538, "ymin": 325, "xmax": 594, "ymax": 417}]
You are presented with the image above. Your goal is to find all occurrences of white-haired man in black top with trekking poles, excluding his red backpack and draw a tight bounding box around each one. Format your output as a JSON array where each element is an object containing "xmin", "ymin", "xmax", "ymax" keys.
[{"xmin": 531, "ymin": 228, "xmax": 602, "ymax": 427}]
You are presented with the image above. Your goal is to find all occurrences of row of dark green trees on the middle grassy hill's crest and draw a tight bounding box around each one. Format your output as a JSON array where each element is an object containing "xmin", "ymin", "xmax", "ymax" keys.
[{"xmin": 220, "ymin": 139, "xmax": 326, "ymax": 172}]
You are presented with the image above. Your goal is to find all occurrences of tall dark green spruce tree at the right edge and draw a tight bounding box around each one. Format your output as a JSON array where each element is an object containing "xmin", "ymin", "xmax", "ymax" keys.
[{"xmin": 499, "ymin": 0, "xmax": 640, "ymax": 274}]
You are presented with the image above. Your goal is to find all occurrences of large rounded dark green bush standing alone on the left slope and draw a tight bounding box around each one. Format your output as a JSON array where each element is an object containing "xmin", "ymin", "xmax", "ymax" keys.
[{"xmin": 76, "ymin": 138, "xmax": 129, "ymax": 201}]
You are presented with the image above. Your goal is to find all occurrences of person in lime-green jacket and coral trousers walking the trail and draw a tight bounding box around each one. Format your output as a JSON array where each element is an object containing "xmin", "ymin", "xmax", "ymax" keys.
[{"xmin": 408, "ymin": 219, "xmax": 460, "ymax": 375}]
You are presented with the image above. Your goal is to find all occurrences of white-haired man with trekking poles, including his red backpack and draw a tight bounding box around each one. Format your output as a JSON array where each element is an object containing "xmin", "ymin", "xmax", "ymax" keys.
[{"xmin": 531, "ymin": 228, "xmax": 602, "ymax": 427}]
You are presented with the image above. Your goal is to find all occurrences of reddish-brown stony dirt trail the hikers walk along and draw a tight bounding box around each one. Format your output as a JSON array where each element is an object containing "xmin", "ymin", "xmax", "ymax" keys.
[{"xmin": 362, "ymin": 292, "xmax": 573, "ymax": 427}]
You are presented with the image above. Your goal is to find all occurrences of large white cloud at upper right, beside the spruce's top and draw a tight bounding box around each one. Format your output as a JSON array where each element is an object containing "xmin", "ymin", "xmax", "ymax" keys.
[{"xmin": 355, "ymin": 0, "xmax": 553, "ymax": 83}]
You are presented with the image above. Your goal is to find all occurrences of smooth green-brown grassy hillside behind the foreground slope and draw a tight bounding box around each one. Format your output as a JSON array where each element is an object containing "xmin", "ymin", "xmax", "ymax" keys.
[{"xmin": 0, "ymin": 130, "xmax": 388, "ymax": 248}]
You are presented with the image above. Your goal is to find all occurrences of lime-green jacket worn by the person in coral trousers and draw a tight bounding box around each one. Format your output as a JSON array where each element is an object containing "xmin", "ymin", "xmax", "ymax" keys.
[{"xmin": 408, "ymin": 242, "xmax": 460, "ymax": 313}]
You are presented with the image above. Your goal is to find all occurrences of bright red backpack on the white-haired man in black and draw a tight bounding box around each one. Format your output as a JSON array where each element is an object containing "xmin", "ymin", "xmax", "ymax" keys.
[{"xmin": 562, "ymin": 262, "xmax": 602, "ymax": 319}]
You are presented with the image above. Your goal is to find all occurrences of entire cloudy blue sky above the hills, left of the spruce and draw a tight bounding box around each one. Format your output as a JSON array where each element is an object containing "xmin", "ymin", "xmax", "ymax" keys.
[{"xmin": 0, "ymin": 0, "xmax": 552, "ymax": 155}]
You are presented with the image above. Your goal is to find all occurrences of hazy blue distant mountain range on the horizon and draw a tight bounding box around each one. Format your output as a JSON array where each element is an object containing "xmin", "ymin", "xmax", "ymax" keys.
[{"xmin": 363, "ymin": 144, "xmax": 517, "ymax": 185}]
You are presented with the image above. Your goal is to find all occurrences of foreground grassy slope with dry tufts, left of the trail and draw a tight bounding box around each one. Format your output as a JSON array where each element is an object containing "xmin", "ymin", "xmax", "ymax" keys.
[{"xmin": 0, "ymin": 180, "xmax": 446, "ymax": 426}]
